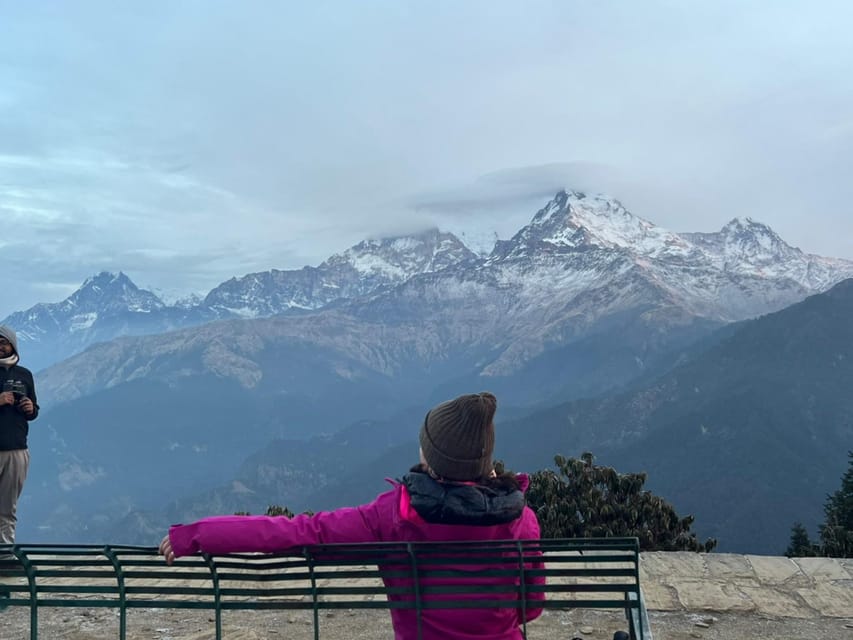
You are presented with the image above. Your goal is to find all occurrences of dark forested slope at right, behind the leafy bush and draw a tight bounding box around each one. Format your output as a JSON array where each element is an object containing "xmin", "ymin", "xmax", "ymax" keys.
[{"xmin": 490, "ymin": 280, "xmax": 853, "ymax": 554}]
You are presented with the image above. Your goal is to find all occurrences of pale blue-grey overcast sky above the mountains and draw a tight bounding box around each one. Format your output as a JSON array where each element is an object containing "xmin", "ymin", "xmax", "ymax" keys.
[{"xmin": 0, "ymin": 0, "xmax": 853, "ymax": 318}]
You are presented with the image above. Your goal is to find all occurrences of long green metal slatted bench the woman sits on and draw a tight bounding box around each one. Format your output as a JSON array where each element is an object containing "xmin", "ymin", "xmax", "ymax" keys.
[{"xmin": 0, "ymin": 538, "xmax": 651, "ymax": 640}]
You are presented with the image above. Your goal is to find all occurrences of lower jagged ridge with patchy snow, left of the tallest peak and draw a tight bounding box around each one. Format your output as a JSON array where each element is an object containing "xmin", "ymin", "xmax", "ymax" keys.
[{"xmin": 3, "ymin": 229, "xmax": 474, "ymax": 370}]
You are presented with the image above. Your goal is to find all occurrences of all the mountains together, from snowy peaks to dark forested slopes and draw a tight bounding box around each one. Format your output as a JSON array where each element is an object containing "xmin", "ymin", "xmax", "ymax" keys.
[{"xmin": 10, "ymin": 191, "xmax": 853, "ymax": 553}]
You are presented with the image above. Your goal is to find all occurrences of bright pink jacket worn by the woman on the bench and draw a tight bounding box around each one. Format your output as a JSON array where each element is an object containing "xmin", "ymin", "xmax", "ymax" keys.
[{"xmin": 169, "ymin": 475, "xmax": 544, "ymax": 640}]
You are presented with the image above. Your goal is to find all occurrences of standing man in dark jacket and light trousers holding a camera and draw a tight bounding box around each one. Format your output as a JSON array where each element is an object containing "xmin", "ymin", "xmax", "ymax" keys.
[{"xmin": 0, "ymin": 325, "xmax": 38, "ymax": 544}]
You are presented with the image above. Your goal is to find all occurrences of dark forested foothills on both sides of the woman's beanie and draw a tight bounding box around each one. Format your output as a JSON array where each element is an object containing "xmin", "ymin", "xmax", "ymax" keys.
[{"xmin": 113, "ymin": 279, "xmax": 853, "ymax": 555}]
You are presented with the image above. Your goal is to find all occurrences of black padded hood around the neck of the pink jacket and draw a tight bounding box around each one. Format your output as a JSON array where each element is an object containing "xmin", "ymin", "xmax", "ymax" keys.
[{"xmin": 401, "ymin": 471, "xmax": 525, "ymax": 527}]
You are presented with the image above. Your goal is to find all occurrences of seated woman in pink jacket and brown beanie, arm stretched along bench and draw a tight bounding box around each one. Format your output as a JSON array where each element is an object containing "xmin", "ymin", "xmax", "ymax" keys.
[{"xmin": 160, "ymin": 393, "xmax": 544, "ymax": 640}]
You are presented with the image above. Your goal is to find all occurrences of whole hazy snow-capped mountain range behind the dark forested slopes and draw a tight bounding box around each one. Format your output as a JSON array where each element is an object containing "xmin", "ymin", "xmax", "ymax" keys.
[{"xmin": 11, "ymin": 192, "xmax": 853, "ymax": 551}]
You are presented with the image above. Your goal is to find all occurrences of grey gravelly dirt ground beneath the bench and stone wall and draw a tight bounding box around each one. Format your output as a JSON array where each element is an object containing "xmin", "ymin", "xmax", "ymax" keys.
[{"xmin": 0, "ymin": 607, "xmax": 853, "ymax": 640}]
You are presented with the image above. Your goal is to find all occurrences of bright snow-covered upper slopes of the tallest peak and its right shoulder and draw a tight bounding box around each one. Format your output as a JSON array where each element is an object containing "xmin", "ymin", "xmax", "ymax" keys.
[{"xmin": 488, "ymin": 191, "xmax": 853, "ymax": 321}]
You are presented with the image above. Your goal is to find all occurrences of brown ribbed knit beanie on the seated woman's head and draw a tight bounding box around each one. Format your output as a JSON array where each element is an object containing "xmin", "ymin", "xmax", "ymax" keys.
[{"xmin": 420, "ymin": 392, "xmax": 498, "ymax": 480}]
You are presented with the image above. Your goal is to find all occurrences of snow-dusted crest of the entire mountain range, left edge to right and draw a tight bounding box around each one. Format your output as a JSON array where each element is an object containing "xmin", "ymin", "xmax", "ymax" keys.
[{"xmin": 8, "ymin": 191, "xmax": 853, "ymax": 371}]
